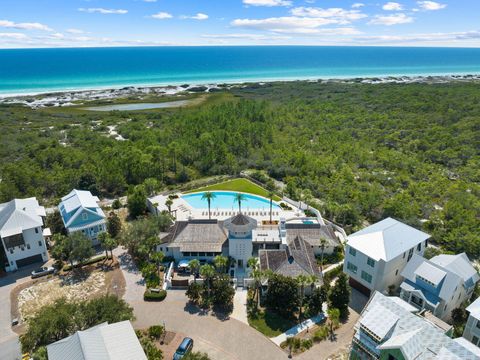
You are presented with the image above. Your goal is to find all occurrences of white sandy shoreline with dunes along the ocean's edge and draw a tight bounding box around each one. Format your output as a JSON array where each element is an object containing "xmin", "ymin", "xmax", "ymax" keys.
[{"xmin": 0, "ymin": 73, "xmax": 480, "ymax": 108}]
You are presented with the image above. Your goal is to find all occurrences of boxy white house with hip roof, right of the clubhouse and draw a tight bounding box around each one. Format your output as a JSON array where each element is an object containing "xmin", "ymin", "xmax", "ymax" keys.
[{"xmin": 343, "ymin": 218, "xmax": 430, "ymax": 296}]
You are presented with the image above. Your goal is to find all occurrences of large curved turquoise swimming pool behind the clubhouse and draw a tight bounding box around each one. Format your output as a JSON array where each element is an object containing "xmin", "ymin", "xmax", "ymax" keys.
[{"xmin": 181, "ymin": 191, "xmax": 280, "ymax": 210}]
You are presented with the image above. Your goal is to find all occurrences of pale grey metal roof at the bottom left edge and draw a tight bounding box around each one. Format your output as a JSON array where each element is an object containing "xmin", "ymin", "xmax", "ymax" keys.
[{"xmin": 47, "ymin": 320, "xmax": 147, "ymax": 360}]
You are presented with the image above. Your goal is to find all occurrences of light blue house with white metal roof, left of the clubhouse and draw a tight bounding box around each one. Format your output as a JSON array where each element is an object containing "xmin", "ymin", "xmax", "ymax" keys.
[{"xmin": 58, "ymin": 189, "xmax": 106, "ymax": 245}]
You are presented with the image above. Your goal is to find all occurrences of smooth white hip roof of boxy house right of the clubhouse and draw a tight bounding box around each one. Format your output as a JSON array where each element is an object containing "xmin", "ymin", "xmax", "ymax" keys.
[{"xmin": 347, "ymin": 218, "xmax": 430, "ymax": 261}]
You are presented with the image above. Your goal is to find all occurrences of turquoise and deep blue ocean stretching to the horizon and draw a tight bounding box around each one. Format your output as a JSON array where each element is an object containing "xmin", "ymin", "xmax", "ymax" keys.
[{"xmin": 0, "ymin": 46, "xmax": 480, "ymax": 95}]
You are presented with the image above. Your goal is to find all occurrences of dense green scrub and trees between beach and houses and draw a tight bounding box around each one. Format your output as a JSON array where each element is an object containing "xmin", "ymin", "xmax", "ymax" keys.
[{"xmin": 0, "ymin": 81, "xmax": 480, "ymax": 257}]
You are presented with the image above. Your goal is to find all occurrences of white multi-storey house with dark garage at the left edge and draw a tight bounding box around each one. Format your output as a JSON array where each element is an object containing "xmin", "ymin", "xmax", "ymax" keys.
[{"xmin": 0, "ymin": 197, "xmax": 50, "ymax": 271}]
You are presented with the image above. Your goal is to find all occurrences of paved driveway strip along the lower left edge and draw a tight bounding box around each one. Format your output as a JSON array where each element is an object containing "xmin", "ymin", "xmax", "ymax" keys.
[{"xmin": 0, "ymin": 264, "xmax": 43, "ymax": 360}]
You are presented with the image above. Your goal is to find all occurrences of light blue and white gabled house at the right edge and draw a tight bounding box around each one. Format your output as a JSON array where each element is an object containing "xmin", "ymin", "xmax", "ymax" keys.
[{"xmin": 400, "ymin": 253, "xmax": 479, "ymax": 321}]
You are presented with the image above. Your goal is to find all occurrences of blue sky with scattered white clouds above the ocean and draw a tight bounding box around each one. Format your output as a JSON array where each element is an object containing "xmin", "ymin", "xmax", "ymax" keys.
[{"xmin": 0, "ymin": 0, "xmax": 480, "ymax": 48}]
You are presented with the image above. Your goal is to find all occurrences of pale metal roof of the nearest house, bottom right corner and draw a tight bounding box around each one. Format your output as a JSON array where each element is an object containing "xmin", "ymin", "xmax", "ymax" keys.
[{"xmin": 354, "ymin": 292, "xmax": 479, "ymax": 360}]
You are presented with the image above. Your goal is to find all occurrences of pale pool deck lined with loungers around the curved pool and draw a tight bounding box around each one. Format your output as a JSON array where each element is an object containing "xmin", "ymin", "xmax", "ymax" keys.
[{"xmin": 148, "ymin": 193, "xmax": 305, "ymax": 221}]
